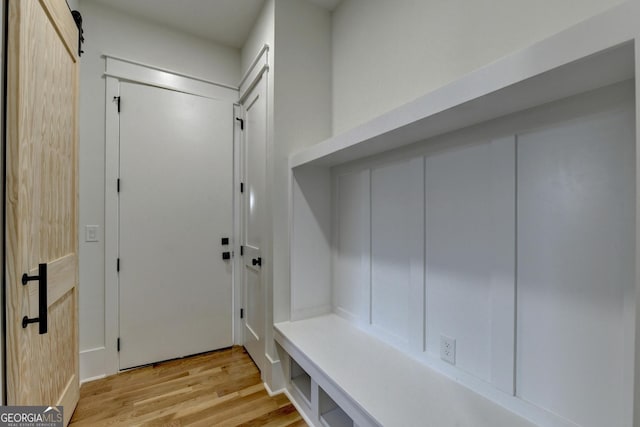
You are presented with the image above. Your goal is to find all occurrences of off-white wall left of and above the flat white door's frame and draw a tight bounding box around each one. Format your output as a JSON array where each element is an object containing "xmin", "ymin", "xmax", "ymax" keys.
[{"xmin": 79, "ymin": 0, "xmax": 240, "ymax": 379}]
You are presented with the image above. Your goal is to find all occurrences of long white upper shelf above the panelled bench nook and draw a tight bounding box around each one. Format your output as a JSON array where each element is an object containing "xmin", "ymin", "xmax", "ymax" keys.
[{"xmin": 289, "ymin": 0, "xmax": 640, "ymax": 168}]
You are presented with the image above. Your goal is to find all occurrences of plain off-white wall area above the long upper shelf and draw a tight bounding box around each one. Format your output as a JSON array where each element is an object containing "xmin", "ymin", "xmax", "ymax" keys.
[{"xmin": 332, "ymin": 0, "xmax": 622, "ymax": 134}]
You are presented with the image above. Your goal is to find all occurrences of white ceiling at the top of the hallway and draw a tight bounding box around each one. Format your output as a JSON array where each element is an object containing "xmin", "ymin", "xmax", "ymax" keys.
[{"xmin": 91, "ymin": 0, "xmax": 341, "ymax": 48}]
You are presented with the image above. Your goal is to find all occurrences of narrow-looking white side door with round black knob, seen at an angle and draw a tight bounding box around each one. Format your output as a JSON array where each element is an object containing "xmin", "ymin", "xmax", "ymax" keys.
[{"xmin": 242, "ymin": 77, "xmax": 267, "ymax": 370}]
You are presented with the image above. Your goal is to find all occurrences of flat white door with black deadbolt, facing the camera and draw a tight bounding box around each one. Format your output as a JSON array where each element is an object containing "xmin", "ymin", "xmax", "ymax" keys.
[{"xmin": 119, "ymin": 83, "xmax": 233, "ymax": 369}]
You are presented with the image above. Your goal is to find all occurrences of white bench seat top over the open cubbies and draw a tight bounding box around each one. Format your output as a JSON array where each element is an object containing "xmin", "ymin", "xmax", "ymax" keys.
[{"xmin": 275, "ymin": 314, "xmax": 533, "ymax": 427}]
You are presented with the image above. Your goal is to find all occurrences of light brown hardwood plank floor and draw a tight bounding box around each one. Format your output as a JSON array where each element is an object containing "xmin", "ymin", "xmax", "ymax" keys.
[{"xmin": 70, "ymin": 347, "xmax": 306, "ymax": 427}]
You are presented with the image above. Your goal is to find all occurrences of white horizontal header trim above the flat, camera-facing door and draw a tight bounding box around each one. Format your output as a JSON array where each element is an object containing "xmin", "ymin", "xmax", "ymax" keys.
[{"xmin": 103, "ymin": 55, "xmax": 238, "ymax": 102}]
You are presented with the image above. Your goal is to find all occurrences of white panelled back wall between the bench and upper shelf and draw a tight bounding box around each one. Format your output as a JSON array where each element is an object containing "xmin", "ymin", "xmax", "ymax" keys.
[{"xmin": 332, "ymin": 82, "xmax": 635, "ymax": 427}]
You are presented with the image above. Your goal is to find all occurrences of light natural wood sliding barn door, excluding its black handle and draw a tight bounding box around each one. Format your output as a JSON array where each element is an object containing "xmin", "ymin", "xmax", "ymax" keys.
[{"xmin": 6, "ymin": 0, "xmax": 79, "ymax": 422}]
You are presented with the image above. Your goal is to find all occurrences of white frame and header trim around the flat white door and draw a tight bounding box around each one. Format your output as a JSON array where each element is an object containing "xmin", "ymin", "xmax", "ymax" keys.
[{"xmin": 103, "ymin": 55, "xmax": 242, "ymax": 375}]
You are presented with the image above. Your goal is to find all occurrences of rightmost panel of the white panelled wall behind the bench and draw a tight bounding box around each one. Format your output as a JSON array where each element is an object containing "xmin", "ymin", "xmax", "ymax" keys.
[{"xmin": 515, "ymin": 97, "xmax": 637, "ymax": 426}]
